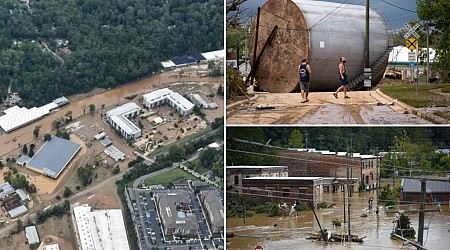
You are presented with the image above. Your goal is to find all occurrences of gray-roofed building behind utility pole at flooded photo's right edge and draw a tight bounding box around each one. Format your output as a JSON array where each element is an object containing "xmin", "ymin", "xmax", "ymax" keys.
[{"xmin": 400, "ymin": 179, "xmax": 450, "ymax": 203}]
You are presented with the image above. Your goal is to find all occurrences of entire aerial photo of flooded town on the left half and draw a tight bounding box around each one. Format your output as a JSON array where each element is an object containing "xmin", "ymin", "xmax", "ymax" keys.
[{"xmin": 0, "ymin": 0, "xmax": 225, "ymax": 250}]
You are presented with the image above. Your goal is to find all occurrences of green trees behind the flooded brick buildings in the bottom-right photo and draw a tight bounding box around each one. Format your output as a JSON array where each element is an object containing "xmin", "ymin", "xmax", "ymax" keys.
[{"xmin": 226, "ymin": 127, "xmax": 450, "ymax": 170}]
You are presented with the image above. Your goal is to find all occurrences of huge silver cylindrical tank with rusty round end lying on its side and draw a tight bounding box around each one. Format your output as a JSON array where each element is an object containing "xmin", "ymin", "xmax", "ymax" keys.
[{"xmin": 249, "ymin": 0, "xmax": 389, "ymax": 93}]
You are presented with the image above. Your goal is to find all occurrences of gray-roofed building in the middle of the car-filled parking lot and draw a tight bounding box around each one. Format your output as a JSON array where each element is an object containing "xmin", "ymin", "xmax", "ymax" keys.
[{"xmin": 156, "ymin": 191, "xmax": 199, "ymax": 236}]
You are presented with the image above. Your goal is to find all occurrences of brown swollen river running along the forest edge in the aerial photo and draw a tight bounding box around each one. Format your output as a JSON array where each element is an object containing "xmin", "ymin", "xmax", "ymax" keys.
[{"xmin": 0, "ymin": 71, "xmax": 223, "ymax": 157}]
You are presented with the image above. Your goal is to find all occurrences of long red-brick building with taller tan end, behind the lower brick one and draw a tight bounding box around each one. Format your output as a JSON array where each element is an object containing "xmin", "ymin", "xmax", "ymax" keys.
[{"xmin": 279, "ymin": 149, "xmax": 380, "ymax": 190}]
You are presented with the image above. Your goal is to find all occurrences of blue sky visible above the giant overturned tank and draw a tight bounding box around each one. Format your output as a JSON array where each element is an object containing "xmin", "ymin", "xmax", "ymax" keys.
[{"xmin": 244, "ymin": 0, "xmax": 418, "ymax": 29}]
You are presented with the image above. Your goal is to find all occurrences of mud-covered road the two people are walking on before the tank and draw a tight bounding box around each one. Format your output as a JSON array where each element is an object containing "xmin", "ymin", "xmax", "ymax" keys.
[{"xmin": 227, "ymin": 91, "xmax": 431, "ymax": 124}]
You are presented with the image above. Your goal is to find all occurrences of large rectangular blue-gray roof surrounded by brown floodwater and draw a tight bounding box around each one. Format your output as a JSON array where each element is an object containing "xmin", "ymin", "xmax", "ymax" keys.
[{"xmin": 27, "ymin": 136, "xmax": 81, "ymax": 178}]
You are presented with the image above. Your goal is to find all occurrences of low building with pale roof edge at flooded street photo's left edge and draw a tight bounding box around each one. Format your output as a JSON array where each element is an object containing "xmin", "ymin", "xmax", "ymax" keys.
[{"xmin": 226, "ymin": 166, "xmax": 289, "ymax": 187}]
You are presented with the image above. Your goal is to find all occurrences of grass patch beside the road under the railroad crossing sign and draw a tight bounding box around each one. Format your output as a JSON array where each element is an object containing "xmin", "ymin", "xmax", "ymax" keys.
[{"xmin": 378, "ymin": 81, "xmax": 450, "ymax": 108}]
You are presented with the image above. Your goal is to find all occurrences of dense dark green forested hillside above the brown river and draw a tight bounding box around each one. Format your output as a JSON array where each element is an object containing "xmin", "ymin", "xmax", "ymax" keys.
[{"xmin": 0, "ymin": 0, "xmax": 223, "ymax": 106}]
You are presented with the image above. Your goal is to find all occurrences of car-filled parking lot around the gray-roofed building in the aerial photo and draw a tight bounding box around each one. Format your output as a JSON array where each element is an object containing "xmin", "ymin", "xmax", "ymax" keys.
[{"xmin": 130, "ymin": 188, "xmax": 224, "ymax": 250}]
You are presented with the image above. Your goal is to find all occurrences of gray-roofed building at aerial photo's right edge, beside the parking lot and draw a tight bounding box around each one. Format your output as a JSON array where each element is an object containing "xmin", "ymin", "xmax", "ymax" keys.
[{"xmin": 200, "ymin": 190, "xmax": 224, "ymax": 233}]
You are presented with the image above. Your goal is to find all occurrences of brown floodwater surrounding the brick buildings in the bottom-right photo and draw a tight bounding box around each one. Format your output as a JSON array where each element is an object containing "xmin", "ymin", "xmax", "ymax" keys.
[{"xmin": 227, "ymin": 192, "xmax": 450, "ymax": 249}]
